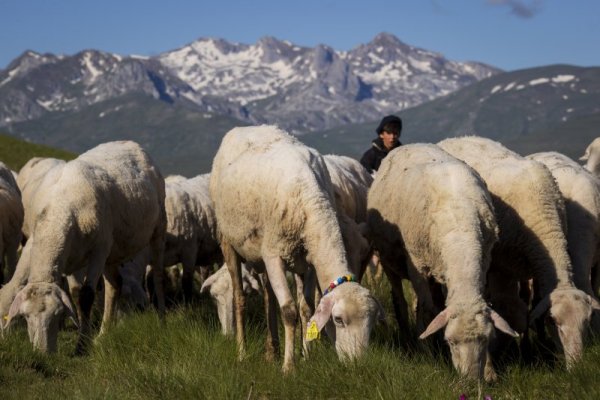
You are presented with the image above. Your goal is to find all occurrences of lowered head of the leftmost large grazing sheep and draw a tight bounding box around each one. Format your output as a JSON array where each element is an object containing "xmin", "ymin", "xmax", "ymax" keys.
[{"xmin": 6, "ymin": 282, "xmax": 77, "ymax": 352}]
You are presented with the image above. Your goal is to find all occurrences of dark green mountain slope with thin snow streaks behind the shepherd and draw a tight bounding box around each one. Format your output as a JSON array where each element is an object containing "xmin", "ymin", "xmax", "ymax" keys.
[{"xmin": 302, "ymin": 65, "xmax": 600, "ymax": 159}]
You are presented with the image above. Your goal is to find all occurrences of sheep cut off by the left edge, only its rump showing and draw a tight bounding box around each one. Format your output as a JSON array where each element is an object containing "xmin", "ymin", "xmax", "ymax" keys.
[{"xmin": 0, "ymin": 161, "xmax": 24, "ymax": 285}]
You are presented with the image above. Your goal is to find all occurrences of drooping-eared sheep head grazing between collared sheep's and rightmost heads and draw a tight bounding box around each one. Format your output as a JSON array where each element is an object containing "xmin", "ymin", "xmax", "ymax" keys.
[{"xmin": 419, "ymin": 303, "xmax": 518, "ymax": 380}]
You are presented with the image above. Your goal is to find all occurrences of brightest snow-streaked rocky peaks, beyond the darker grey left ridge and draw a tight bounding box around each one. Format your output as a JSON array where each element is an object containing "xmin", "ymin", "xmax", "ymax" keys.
[{"xmin": 157, "ymin": 33, "xmax": 500, "ymax": 134}]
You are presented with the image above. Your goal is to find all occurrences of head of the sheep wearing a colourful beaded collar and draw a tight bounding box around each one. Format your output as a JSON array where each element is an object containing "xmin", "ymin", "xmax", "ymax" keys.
[{"xmin": 308, "ymin": 282, "xmax": 385, "ymax": 360}]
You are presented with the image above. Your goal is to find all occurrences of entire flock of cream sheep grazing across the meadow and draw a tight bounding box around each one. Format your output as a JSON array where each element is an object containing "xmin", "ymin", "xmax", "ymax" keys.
[{"xmin": 0, "ymin": 125, "xmax": 600, "ymax": 380}]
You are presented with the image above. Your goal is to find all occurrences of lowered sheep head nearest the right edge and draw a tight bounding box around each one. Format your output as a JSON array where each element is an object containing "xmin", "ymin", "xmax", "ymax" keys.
[{"xmin": 530, "ymin": 288, "xmax": 600, "ymax": 369}]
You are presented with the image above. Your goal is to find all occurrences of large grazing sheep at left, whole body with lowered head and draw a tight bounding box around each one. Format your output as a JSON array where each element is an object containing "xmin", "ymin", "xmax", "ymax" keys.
[{"xmin": 0, "ymin": 141, "xmax": 166, "ymax": 353}]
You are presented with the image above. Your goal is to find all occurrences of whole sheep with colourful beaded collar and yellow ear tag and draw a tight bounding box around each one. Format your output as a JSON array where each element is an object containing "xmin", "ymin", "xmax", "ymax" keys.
[{"xmin": 210, "ymin": 125, "xmax": 383, "ymax": 372}]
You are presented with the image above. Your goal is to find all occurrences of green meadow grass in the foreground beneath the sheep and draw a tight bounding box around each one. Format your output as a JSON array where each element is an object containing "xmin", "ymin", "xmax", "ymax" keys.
[{"xmin": 0, "ymin": 282, "xmax": 600, "ymax": 400}]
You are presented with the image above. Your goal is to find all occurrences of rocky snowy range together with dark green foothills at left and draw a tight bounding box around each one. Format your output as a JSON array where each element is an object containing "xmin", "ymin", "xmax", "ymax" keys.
[{"xmin": 0, "ymin": 33, "xmax": 500, "ymax": 173}]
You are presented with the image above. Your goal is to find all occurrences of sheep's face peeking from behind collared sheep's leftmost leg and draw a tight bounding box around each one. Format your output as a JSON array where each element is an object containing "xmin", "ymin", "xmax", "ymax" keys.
[{"xmin": 200, "ymin": 264, "xmax": 262, "ymax": 335}]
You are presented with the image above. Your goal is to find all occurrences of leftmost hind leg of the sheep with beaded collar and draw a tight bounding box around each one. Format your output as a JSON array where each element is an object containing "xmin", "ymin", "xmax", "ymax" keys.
[{"xmin": 221, "ymin": 240, "xmax": 246, "ymax": 361}]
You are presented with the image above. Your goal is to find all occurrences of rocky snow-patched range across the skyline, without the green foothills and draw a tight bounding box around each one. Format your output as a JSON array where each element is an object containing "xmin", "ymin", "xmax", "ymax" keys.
[{"xmin": 0, "ymin": 33, "xmax": 500, "ymax": 133}]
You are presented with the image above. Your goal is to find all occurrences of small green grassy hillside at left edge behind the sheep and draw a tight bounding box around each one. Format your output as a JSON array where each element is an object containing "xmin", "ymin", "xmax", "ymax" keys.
[{"xmin": 0, "ymin": 133, "xmax": 77, "ymax": 172}]
